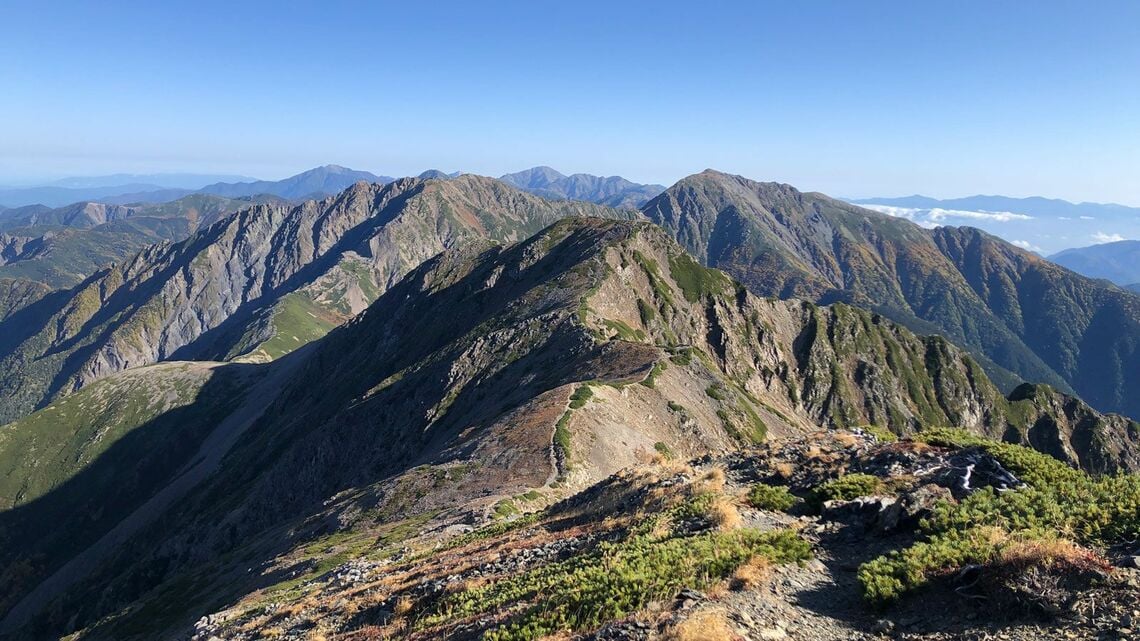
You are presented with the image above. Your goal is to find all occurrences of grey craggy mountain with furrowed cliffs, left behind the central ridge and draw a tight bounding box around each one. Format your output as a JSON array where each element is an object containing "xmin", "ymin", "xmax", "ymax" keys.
[{"xmin": 0, "ymin": 176, "xmax": 634, "ymax": 420}]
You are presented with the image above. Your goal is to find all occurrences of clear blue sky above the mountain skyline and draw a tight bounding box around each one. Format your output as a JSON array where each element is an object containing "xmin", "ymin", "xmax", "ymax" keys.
[{"xmin": 0, "ymin": 0, "xmax": 1140, "ymax": 205}]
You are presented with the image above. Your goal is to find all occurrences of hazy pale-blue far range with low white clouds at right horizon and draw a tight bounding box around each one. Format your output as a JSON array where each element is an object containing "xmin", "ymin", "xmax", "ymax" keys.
[{"xmin": 850, "ymin": 196, "xmax": 1140, "ymax": 254}]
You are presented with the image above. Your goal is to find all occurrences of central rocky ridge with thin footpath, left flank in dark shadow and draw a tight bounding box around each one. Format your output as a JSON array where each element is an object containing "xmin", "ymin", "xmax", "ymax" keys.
[{"xmin": 0, "ymin": 216, "xmax": 1140, "ymax": 639}]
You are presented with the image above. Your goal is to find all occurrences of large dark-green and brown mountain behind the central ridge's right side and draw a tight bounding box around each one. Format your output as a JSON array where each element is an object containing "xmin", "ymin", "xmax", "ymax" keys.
[{"xmin": 642, "ymin": 170, "xmax": 1140, "ymax": 415}]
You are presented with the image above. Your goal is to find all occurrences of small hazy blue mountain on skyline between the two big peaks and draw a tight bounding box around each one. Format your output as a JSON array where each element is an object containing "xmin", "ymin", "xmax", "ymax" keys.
[{"xmin": 499, "ymin": 167, "xmax": 665, "ymax": 208}]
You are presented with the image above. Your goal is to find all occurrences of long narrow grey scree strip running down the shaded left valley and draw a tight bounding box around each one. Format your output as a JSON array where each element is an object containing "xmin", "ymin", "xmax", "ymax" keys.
[{"xmin": 0, "ymin": 348, "xmax": 308, "ymax": 634}]
